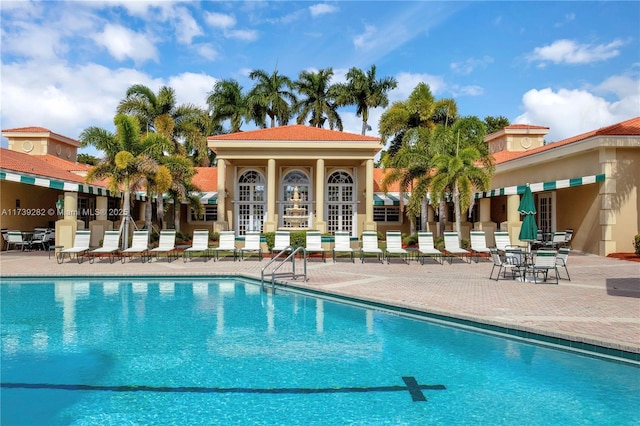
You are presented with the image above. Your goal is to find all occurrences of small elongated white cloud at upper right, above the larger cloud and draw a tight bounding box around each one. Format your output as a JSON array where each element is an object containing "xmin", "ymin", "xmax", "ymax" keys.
[{"xmin": 528, "ymin": 39, "xmax": 624, "ymax": 67}]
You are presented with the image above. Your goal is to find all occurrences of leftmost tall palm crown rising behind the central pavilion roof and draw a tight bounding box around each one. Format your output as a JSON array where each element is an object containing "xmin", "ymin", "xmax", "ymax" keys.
[{"xmin": 207, "ymin": 80, "xmax": 251, "ymax": 133}]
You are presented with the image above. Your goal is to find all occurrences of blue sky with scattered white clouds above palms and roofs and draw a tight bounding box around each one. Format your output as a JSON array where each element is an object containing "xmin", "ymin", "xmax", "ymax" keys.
[{"xmin": 0, "ymin": 0, "xmax": 640, "ymax": 153}]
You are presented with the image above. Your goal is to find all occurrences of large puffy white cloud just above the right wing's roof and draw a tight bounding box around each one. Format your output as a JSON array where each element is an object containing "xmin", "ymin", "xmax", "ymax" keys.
[{"xmin": 514, "ymin": 76, "xmax": 640, "ymax": 141}]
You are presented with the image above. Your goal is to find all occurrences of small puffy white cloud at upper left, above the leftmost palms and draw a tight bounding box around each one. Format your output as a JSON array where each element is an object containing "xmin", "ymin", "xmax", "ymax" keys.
[{"xmin": 93, "ymin": 24, "xmax": 158, "ymax": 64}]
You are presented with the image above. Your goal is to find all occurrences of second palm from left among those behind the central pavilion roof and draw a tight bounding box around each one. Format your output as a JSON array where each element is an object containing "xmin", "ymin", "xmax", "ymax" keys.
[{"xmin": 248, "ymin": 70, "xmax": 296, "ymax": 127}]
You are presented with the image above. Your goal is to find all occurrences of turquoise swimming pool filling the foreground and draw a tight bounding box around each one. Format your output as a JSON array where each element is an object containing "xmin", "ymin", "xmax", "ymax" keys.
[{"xmin": 0, "ymin": 278, "xmax": 640, "ymax": 425}]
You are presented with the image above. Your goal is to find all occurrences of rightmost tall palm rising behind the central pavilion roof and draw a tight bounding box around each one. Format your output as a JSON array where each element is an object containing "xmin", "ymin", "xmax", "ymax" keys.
[{"xmin": 336, "ymin": 65, "xmax": 398, "ymax": 136}]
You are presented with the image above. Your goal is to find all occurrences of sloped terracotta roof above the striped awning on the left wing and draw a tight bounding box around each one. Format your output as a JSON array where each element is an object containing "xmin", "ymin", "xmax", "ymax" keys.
[{"xmin": 0, "ymin": 148, "xmax": 90, "ymax": 183}]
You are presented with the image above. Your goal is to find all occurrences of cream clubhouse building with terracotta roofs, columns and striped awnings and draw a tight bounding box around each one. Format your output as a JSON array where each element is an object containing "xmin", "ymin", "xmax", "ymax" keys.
[{"xmin": 0, "ymin": 117, "xmax": 640, "ymax": 256}]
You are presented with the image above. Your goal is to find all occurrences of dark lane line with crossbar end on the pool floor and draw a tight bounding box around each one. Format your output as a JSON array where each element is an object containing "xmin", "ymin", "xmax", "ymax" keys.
[{"xmin": 0, "ymin": 376, "xmax": 446, "ymax": 402}]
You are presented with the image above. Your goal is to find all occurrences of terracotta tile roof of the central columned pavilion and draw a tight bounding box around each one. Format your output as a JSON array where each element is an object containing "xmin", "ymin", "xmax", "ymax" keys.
[{"xmin": 207, "ymin": 124, "xmax": 380, "ymax": 142}]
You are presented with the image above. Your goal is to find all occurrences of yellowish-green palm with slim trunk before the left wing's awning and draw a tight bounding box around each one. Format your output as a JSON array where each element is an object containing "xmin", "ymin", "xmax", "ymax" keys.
[{"xmin": 80, "ymin": 114, "xmax": 172, "ymax": 248}]
